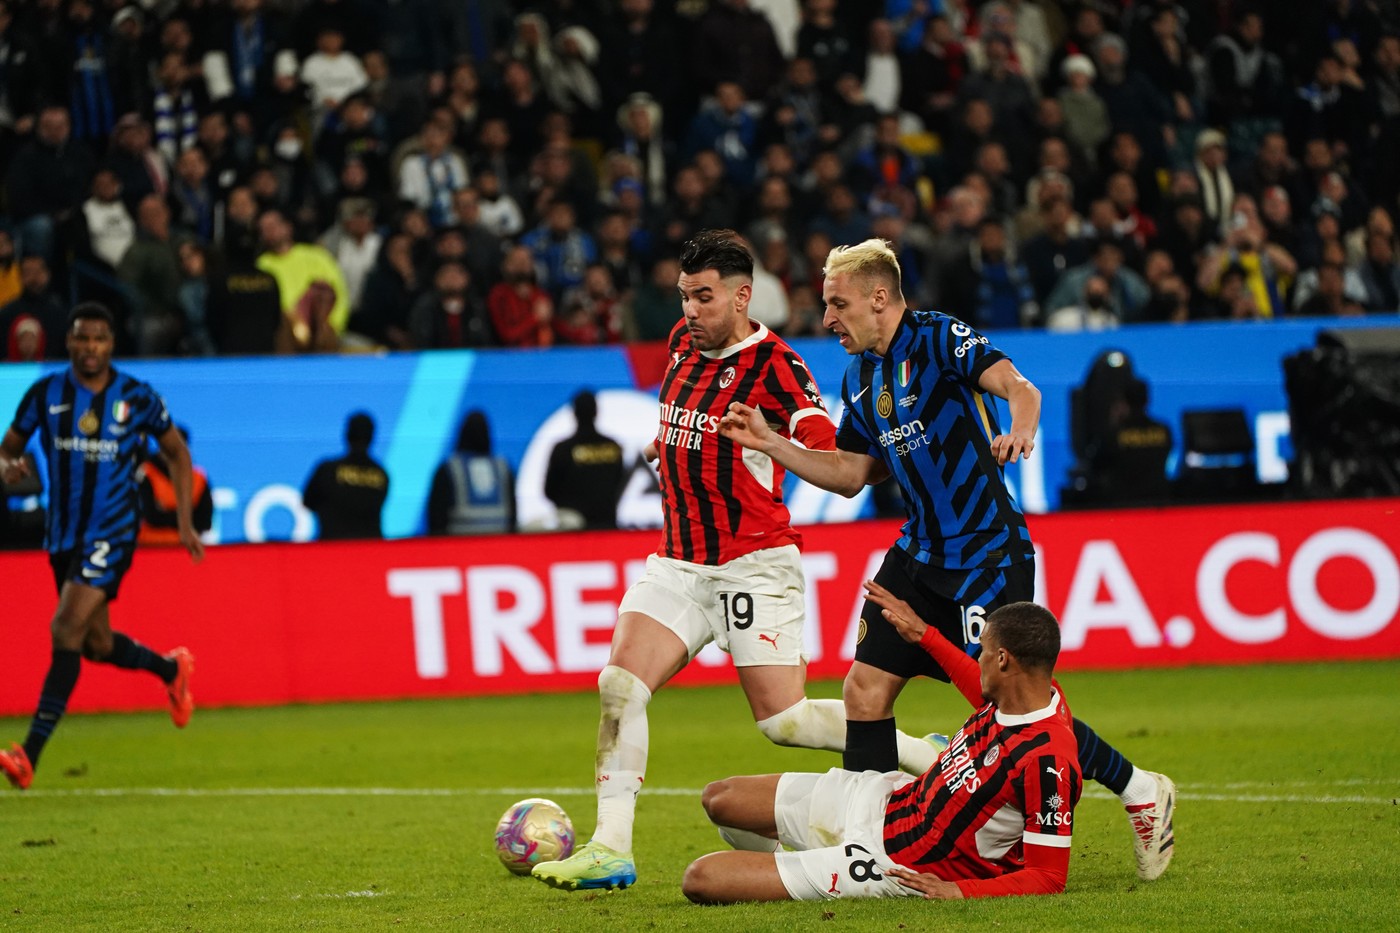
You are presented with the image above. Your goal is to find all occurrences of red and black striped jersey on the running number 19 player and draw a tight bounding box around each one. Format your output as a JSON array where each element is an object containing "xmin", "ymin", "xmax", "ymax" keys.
[{"xmin": 657, "ymin": 321, "xmax": 836, "ymax": 565}]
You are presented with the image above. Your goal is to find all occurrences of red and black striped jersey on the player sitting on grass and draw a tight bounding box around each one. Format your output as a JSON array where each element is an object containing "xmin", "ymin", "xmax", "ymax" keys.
[{"xmin": 885, "ymin": 629, "xmax": 1084, "ymax": 897}]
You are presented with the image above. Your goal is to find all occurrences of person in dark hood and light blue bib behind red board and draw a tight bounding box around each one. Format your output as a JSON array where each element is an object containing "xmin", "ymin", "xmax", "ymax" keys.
[{"xmin": 427, "ymin": 409, "xmax": 515, "ymax": 535}]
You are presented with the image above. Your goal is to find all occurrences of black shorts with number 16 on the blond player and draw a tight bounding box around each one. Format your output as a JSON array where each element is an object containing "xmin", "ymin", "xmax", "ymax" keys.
[{"xmin": 855, "ymin": 546, "xmax": 1036, "ymax": 684}]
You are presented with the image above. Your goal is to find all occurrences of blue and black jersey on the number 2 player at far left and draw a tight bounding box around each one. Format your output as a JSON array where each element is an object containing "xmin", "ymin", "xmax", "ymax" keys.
[{"xmin": 11, "ymin": 368, "xmax": 171, "ymax": 553}]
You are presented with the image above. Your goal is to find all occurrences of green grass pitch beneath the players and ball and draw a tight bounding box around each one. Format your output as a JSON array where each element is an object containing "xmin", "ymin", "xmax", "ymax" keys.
[{"xmin": 0, "ymin": 661, "xmax": 1400, "ymax": 933}]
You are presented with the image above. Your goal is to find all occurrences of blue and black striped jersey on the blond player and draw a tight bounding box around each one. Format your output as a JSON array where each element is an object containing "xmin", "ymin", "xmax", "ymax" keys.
[{"xmin": 836, "ymin": 310, "xmax": 1035, "ymax": 570}]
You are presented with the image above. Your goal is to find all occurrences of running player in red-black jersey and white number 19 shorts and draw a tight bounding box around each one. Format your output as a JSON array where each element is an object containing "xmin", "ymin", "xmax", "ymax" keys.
[{"xmin": 533, "ymin": 230, "xmax": 937, "ymax": 890}]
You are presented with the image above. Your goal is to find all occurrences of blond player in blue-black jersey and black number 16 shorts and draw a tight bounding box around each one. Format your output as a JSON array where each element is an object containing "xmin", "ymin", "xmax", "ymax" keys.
[{"xmin": 720, "ymin": 240, "xmax": 1176, "ymax": 881}]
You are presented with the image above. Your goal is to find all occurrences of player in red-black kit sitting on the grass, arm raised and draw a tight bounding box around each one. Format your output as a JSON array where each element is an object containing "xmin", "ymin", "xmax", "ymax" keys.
[{"xmin": 682, "ymin": 596, "xmax": 1082, "ymax": 904}]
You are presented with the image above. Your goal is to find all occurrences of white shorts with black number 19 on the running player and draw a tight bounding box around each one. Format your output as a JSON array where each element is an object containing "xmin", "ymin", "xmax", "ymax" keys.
[{"xmin": 617, "ymin": 545, "xmax": 806, "ymax": 667}]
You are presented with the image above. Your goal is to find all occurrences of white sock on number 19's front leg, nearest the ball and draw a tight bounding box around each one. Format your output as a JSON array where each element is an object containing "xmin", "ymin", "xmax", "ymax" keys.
[{"xmin": 594, "ymin": 664, "xmax": 651, "ymax": 852}]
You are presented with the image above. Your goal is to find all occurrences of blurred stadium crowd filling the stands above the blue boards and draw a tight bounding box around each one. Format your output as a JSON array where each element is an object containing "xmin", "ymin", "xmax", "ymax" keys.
[{"xmin": 0, "ymin": 0, "xmax": 1400, "ymax": 360}]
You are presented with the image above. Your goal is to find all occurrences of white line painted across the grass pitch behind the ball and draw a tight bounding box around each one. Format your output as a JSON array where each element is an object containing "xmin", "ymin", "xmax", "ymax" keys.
[{"xmin": 0, "ymin": 780, "xmax": 1400, "ymax": 806}]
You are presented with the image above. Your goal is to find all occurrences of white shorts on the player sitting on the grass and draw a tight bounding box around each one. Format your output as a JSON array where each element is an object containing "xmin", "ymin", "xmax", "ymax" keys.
[{"xmin": 774, "ymin": 768, "xmax": 920, "ymax": 901}]
